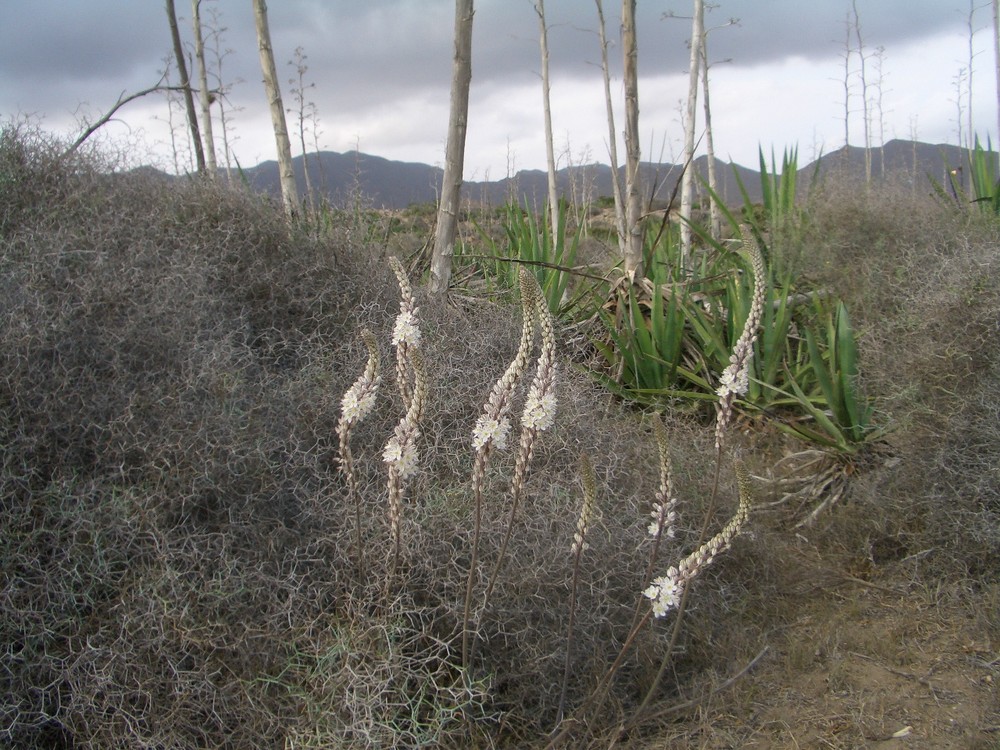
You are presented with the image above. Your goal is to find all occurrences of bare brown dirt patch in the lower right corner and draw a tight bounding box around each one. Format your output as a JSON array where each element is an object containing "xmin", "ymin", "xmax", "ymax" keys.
[{"xmin": 644, "ymin": 548, "xmax": 1000, "ymax": 750}]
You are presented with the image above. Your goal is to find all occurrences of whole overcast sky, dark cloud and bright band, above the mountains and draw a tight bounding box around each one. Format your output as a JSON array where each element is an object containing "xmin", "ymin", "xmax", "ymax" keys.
[{"xmin": 0, "ymin": 0, "xmax": 997, "ymax": 180}]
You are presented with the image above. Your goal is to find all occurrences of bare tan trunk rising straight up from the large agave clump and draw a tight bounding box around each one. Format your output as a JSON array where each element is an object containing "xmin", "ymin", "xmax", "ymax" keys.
[{"xmin": 622, "ymin": 0, "xmax": 643, "ymax": 283}]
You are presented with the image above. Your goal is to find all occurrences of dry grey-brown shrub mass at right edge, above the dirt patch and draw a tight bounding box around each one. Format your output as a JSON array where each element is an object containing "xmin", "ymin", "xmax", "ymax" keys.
[{"xmin": 801, "ymin": 176, "xmax": 1000, "ymax": 578}]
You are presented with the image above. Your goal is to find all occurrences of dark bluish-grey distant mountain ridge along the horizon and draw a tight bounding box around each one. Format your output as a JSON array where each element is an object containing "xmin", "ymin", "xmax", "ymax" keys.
[{"xmin": 234, "ymin": 140, "xmax": 967, "ymax": 209}]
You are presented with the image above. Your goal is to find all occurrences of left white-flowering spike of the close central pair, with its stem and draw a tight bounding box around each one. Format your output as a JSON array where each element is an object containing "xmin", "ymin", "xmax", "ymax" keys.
[{"xmin": 462, "ymin": 268, "xmax": 537, "ymax": 668}]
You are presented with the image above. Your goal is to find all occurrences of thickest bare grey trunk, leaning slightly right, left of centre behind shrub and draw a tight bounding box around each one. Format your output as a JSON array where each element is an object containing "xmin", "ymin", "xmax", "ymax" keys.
[{"xmin": 430, "ymin": 0, "xmax": 475, "ymax": 295}]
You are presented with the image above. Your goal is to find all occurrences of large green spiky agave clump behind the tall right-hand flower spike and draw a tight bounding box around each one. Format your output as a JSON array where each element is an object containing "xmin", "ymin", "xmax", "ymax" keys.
[{"xmin": 593, "ymin": 175, "xmax": 882, "ymax": 455}]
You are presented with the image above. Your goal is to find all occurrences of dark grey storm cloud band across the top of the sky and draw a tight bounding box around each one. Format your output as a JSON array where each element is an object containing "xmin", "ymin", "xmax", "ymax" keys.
[{"xmin": 0, "ymin": 0, "xmax": 965, "ymax": 117}]
